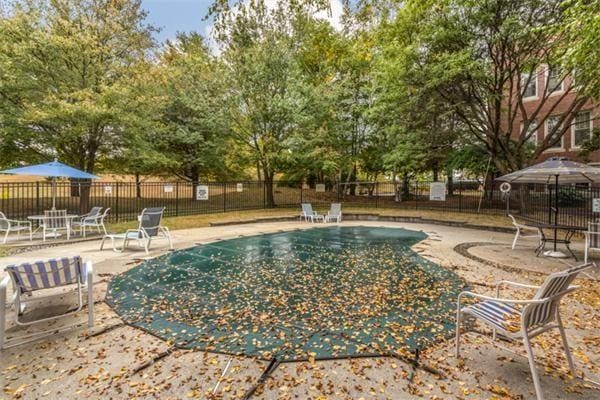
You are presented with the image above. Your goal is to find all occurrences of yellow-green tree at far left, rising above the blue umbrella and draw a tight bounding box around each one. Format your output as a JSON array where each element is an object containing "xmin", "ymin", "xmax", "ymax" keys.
[{"xmin": 0, "ymin": 0, "xmax": 153, "ymax": 172}]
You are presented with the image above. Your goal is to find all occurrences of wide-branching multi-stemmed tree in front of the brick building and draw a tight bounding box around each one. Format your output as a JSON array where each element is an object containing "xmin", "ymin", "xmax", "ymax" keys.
[{"xmin": 399, "ymin": 0, "xmax": 591, "ymax": 173}]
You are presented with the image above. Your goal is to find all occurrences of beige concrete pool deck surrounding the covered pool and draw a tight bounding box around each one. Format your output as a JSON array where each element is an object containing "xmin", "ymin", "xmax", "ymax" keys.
[{"xmin": 0, "ymin": 221, "xmax": 600, "ymax": 399}]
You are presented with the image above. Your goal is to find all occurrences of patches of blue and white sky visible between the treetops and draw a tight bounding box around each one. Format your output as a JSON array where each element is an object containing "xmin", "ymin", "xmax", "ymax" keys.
[{"xmin": 142, "ymin": 0, "xmax": 343, "ymax": 42}]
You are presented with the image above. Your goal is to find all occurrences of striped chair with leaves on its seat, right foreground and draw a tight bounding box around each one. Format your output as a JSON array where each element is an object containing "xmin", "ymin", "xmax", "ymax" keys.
[{"xmin": 456, "ymin": 263, "xmax": 595, "ymax": 399}]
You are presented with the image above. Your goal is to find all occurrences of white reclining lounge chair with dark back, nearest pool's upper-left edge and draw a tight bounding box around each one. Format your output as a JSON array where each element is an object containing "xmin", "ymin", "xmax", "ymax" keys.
[{"xmin": 100, "ymin": 207, "xmax": 173, "ymax": 254}]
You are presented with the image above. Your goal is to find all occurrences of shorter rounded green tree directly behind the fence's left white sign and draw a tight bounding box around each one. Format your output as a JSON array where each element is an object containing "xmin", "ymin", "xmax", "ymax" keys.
[{"xmin": 155, "ymin": 33, "xmax": 241, "ymax": 198}]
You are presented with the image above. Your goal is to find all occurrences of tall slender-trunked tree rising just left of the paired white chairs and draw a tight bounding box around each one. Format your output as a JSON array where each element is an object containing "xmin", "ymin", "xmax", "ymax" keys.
[{"xmin": 216, "ymin": 0, "xmax": 322, "ymax": 207}]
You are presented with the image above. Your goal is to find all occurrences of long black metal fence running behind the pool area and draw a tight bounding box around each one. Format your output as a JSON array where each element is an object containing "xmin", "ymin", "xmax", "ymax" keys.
[{"xmin": 0, "ymin": 181, "xmax": 600, "ymax": 227}]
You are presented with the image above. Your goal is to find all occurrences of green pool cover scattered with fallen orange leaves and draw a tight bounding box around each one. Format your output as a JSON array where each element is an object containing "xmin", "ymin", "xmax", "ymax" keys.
[{"xmin": 107, "ymin": 226, "xmax": 464, "ymax": 361}]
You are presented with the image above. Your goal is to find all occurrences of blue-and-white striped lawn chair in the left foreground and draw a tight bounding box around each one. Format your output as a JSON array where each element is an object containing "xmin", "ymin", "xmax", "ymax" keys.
[{"xmin": 0, "ymin": 256, "xmax": 94, "ymax": 349}]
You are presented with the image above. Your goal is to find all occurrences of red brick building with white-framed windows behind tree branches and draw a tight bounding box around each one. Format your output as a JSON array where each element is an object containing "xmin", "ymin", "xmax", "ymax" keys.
[{"xmin": 512, "ymin": 65, "xmax": 600, "ymax": 165}]
